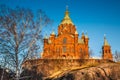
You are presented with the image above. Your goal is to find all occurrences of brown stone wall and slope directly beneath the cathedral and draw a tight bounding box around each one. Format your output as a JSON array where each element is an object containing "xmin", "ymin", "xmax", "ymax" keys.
[{"xmin": 22, "ymin": 59, "xmax": 112, "ymax": 77}]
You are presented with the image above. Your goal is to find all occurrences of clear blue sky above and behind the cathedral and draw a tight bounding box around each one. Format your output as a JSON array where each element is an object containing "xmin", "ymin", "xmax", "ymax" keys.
[{"xmin": 0, "ymin": 0, "xmax": 120, "ymax": 56}]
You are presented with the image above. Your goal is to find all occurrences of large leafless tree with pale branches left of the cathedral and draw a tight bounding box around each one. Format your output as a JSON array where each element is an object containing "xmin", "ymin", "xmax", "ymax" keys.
[{"xmin": 0, "ymin": 5, "xmax": 50, "ymax": 80}]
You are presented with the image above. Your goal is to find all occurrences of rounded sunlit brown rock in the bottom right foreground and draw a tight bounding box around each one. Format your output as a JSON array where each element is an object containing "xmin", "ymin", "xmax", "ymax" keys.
[{"xmin": 48, "ymin": 63, "xmax": 120, "ymax": 80}]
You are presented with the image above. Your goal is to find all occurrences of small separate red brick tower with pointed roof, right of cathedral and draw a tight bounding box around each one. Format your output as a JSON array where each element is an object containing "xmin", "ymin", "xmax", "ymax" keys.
[{"xmin": 102, "ymin": 36, "xmax": 113, "ymax": 60}]
